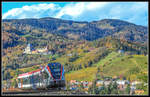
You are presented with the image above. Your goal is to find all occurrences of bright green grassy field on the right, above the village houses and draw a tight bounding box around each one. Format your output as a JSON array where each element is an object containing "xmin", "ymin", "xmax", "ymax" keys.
[{"xmin": 95, "ymin": 52, "xmax": 148, "ymax": 80}]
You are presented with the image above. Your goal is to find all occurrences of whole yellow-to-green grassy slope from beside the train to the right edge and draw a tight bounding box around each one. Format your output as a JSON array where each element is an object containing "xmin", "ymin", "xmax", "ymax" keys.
[{"xmin": 66, "ymin": 52, "xmax": 148, "ymax": 81}]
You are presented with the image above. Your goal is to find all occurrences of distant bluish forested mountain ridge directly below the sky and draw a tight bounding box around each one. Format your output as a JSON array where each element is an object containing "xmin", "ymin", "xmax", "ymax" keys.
[{"xmin": 2, "ymin": 17, "xmax": 148, "ymax": 43}]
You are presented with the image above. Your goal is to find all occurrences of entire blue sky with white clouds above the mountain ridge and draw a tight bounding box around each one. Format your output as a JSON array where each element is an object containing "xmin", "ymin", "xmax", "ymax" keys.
[{"xmin": 2, "ymin": 2, "xmax": 148, "ymax": 26}]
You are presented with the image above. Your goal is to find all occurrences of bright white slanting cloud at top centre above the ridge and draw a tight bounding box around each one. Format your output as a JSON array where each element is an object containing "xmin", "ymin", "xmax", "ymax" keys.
[{"xmin": 56, "ymin": 2, "xmax": 108, "ymax": 18}]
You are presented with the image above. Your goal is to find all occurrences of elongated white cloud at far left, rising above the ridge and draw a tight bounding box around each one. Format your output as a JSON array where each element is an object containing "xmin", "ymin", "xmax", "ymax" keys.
[{"xmin": 2, "ymin": 3, "xmax": 60, "ymax": 19}]
